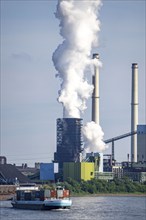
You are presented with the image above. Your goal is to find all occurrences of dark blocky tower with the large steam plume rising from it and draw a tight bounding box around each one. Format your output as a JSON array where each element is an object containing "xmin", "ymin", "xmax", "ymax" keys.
[{"xmin": 54, "ymin": 118, "xmax": 82, "ymax": 169}]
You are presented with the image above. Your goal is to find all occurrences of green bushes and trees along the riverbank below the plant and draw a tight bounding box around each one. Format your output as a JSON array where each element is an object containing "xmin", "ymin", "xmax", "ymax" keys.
[{"xmin": 50, "ymin": 177, "xmax": 146, "ymax": 195}]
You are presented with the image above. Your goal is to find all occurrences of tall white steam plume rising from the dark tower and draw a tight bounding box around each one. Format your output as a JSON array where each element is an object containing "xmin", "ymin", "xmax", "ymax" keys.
[{"xmin": 52, "ymin": 0, "xmax": 101, "ymax": 118}]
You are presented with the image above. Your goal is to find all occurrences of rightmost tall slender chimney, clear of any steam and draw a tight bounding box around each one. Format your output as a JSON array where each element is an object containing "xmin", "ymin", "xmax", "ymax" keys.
[{"xmin": 131, "ymin": 63, "xmax": 138, "ymax": 162}]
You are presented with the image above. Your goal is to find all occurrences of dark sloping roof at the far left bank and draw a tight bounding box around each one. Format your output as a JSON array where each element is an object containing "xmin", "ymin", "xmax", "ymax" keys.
[{"xmin": 0, "ymin": 164, "xmax": 29, "ymax": 184}]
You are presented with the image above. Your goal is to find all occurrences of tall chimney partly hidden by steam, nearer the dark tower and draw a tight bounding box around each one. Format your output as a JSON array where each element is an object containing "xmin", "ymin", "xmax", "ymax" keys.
[{"xmin": 92, "ymin": 54, "xmax": 99, "ymax": 125}]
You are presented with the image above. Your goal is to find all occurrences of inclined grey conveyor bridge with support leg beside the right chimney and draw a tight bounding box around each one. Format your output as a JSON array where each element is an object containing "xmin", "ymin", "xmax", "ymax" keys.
[{"xmin": 104, "ymin": 131, "xmax": 137, "ymax": 161}]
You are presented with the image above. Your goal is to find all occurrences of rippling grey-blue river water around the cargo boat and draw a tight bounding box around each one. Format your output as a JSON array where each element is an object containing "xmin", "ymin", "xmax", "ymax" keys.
[{"xmin": 0, "ymin": 196, "xmax": 146, "ymax": 220}]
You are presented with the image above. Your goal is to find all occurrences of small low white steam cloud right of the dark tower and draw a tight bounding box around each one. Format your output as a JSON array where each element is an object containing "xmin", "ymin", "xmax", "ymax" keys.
[{"xmin": 82, "ymin": 121, "xmax": 107, "ymax": 153}]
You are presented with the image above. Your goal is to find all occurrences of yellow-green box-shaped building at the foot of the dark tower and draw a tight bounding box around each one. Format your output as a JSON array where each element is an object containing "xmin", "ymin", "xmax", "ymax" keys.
[{"xmin": 63, "ymin": 162, "xmax": 95, "ymax": 181}]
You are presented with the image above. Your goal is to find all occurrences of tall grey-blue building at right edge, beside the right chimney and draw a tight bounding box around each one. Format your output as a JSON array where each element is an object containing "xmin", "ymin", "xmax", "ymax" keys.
[{"xmin": 137, "ymin": 125, "xmax": 146, "ymax": 163}]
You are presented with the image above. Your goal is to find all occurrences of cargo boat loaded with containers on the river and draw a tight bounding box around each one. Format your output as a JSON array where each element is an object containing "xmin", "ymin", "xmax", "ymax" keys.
[{"xmin": 11, "ymin": 184, "xmax": 72, "ymax": 210}]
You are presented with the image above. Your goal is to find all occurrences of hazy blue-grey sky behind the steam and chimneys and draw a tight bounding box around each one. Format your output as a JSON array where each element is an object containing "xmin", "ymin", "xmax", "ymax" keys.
[{"xmin": 0, "ymin": 0, "xmax": 146, "ymax": 166}]
